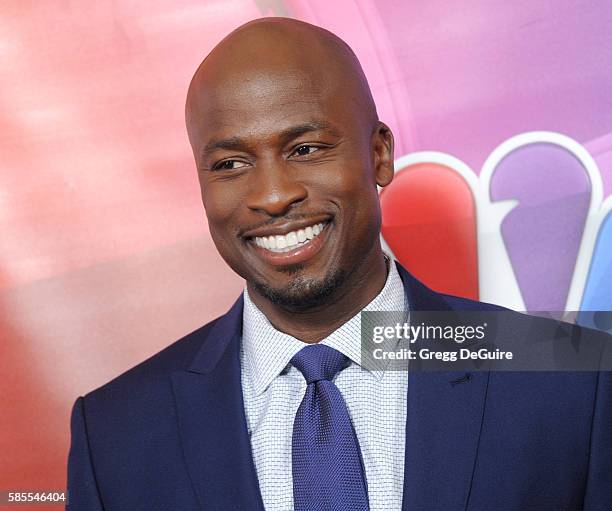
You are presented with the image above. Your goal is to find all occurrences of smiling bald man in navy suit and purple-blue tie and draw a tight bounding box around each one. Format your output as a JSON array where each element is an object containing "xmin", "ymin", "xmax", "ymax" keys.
[{"xmin": 68, "ymin": 18, "xmax": 612, "ymax": 511}]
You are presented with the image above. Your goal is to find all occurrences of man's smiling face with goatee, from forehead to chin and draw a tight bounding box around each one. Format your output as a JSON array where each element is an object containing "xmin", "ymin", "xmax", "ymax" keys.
[{"xmin": 190, "ymin": 65, "xmax": 392, "ymax": 307}]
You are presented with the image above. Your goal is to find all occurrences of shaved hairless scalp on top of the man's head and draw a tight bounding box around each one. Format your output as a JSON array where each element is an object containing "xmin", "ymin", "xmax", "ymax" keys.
[{"xmin": 185, "ymin": 18, "xmax": 378, "ymax": 145}]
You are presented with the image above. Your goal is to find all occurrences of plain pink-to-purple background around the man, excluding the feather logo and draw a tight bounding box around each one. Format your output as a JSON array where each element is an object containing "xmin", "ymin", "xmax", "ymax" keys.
[{"xmin": 0, "ymin": 0, "xmax": 612, "ymax": 509}]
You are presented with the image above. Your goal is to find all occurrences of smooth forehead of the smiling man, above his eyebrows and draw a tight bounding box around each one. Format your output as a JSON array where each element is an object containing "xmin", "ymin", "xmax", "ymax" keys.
[{"xmin": 189, "ymin": 67, "xmax": 359, "ymax": 145}]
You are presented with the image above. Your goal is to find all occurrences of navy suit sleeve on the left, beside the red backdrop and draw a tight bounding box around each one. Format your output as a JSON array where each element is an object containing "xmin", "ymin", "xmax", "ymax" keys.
[{"xmin": 66, "ymin": 397, "xmax": 104, "ymax": 511}]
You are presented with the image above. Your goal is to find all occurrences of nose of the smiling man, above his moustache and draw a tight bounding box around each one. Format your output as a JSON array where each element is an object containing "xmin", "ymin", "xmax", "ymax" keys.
[{"xmin": 246, "ymin": 161, "xmax": 308, "ymax": 216}]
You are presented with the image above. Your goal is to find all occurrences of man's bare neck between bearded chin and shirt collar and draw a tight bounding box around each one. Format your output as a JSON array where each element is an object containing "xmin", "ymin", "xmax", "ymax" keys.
[{"xmin": 248, "ymin": 246, "xmax": 391, "ymax": 343}]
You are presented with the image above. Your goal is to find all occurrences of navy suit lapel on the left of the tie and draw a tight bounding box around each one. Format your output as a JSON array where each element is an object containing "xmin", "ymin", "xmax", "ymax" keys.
[{"xmin": 172, "ymin": 296, "xmax": 263, "ymax": 510}]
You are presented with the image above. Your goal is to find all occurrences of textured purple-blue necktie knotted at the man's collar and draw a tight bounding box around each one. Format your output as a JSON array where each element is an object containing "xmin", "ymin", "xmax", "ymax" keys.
[{"xmin": 291, "ymin": 344, "xmax": 369, "ymax": 511}]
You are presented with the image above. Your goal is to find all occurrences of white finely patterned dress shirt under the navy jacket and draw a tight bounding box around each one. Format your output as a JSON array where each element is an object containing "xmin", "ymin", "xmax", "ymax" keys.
[{"xmin": 240, "ymin": 262, "xmax": 408, "ymax": 511}]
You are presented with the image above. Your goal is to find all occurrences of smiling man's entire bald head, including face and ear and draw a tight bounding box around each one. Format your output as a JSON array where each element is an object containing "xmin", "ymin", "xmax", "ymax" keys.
[{"xmin": 186, "ymin": 18, "xmax": 393, "ymax": 316}]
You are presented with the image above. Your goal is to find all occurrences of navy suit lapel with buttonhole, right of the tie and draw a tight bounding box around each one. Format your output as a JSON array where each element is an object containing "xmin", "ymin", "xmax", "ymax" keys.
[{"xmin": 398, "ymin": 264, "xmax": 489, "ymax": 511}]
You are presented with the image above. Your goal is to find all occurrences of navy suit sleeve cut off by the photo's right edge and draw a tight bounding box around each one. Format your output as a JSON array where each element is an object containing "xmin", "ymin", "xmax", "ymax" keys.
[{"xmin": 584, "ymin": 371, "xmax": 612, "ymax": 511}]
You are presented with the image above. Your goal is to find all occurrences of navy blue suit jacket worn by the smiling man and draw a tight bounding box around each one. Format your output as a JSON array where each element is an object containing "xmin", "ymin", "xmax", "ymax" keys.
[{"xmin": 68, "ymin": 265, "xmax": 612, "ymax": 511}]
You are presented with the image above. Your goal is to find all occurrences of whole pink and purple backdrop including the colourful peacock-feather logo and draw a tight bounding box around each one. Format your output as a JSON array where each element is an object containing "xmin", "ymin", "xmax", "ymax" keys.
[{"xmin": 0, "ymin": 0, "xmax": 612, "ymax": 509}]
